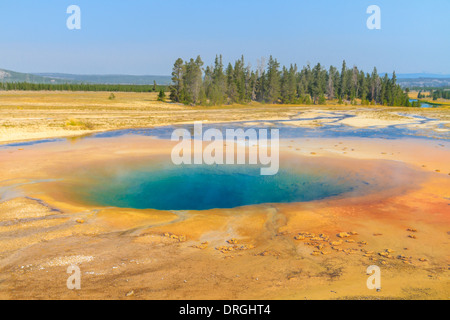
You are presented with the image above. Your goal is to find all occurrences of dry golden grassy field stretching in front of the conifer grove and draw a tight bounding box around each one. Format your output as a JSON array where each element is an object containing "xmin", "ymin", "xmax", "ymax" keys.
[{"xmin": 0, "ymin": 91, "xmax": 450, "ymax": 143}]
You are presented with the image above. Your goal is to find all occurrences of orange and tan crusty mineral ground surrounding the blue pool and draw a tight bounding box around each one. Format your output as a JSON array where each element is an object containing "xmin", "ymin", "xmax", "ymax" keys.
[{"xmin": 0, "ymin": 136, "xmax": 450, "ymax": 299}]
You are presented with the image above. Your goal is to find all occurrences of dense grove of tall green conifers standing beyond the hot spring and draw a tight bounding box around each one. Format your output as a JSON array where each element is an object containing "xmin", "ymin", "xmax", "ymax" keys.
[{"xmin": 170, "ymin": 55, "xmax": 410, "ymax": 106}]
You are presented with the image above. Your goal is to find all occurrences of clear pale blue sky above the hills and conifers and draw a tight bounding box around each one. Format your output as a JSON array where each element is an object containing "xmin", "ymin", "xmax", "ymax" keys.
[{"xmin": 0, "ymin": 0, "xmax": 450, "ymax": 75}]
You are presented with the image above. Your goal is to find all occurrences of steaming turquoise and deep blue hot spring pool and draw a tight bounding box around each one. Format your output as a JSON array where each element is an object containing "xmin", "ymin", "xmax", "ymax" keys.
[{"xmin": 75, "ymin": 165, "xmax": 361, "ymax": 210}]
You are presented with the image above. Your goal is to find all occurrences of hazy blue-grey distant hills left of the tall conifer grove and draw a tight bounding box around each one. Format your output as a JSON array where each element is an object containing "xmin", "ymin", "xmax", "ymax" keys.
[{"xmin": 0, "ymin": 69, "xmax": 171, "ymax": 85}]
